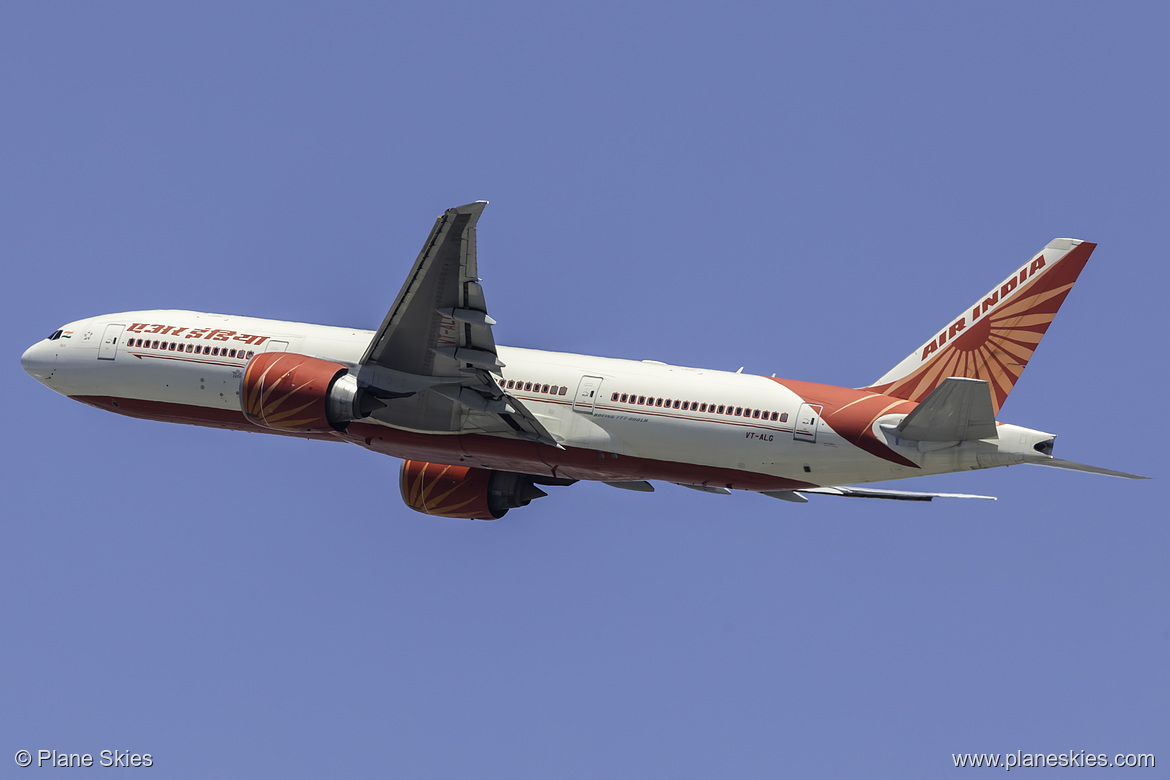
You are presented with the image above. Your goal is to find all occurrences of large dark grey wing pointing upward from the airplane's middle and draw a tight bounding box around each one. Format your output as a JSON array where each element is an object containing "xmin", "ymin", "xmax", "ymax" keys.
[{"xmin": 358, "ymin": 200, "xmax": 556, "ymax": 446}]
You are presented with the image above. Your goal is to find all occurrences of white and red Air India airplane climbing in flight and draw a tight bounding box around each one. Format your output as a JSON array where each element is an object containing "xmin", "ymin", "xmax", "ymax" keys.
[{"xmin": 21, "ymin": 200, "xmax": 1145, "ymax": 520}]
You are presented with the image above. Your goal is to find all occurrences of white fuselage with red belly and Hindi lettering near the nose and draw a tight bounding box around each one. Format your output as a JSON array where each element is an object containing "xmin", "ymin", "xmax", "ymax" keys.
[{"xmin": 22, "ymin": 310, "xmax": 1051, "ymax": 490}]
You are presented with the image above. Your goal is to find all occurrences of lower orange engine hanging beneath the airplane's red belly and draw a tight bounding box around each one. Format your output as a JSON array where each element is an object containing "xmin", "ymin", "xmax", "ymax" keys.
[{"xmin": 401, "ymin": 461, "xmax": 552, "ymax": 520}]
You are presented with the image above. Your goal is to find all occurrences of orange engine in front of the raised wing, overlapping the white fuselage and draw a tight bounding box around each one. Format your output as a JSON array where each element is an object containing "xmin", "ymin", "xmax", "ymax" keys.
[{"xmin": 240, "ymin": 352, "xmax": 358, "ymax": 433}]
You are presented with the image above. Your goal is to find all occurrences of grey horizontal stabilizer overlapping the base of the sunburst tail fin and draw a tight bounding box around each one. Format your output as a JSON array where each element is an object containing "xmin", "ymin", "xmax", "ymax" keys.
[{"xmin": 882, "ymin": 377, "xmax": 998, "ymax": 442}]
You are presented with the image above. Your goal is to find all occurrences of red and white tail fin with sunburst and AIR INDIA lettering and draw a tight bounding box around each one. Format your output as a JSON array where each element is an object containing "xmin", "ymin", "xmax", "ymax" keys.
[{"xmin": 866, "ymin": 239, "xmax": 1096, "ymax": 414}]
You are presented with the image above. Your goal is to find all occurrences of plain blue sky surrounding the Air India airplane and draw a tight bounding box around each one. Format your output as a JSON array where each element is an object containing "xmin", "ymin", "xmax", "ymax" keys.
[{"xmin": 0, "ymin": 2, "xmax": 1170, "ymax": 778}]
